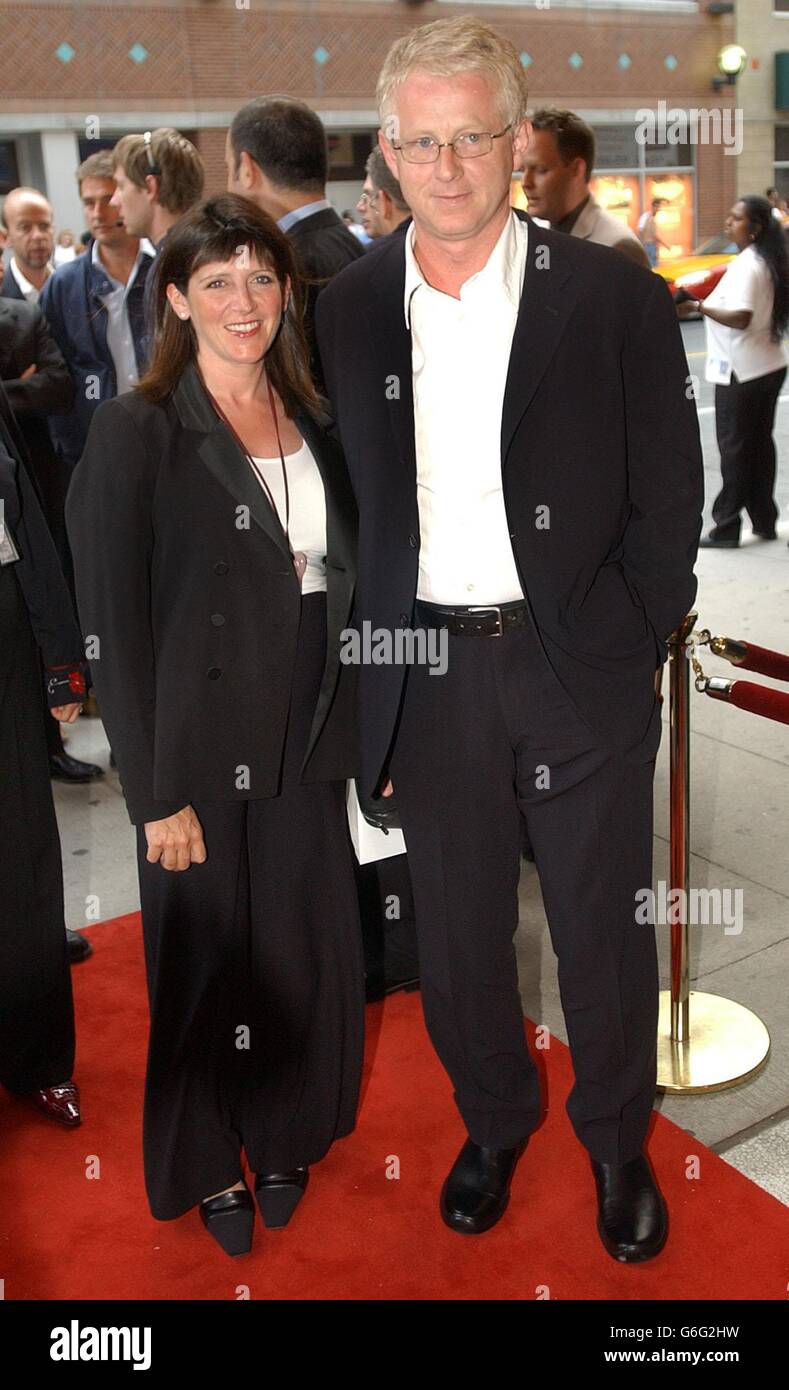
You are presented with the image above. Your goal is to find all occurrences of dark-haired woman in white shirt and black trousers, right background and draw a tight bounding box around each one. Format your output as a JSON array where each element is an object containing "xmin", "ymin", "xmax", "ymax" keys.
[{"xmin": 678, "ymin": 197, "xmax": 789, "ymax": 549}]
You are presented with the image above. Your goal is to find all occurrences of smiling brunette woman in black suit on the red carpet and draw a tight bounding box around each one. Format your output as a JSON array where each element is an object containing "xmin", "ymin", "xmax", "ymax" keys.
[{"xmin": 67, "ymin": 195, "xmax": 364, "ymax": 1254}]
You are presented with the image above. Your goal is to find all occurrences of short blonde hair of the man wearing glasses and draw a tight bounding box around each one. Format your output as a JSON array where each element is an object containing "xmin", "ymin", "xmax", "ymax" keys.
[{"xmin": 375, "ymin": 18, "xmax": 528, "ymax": 133}]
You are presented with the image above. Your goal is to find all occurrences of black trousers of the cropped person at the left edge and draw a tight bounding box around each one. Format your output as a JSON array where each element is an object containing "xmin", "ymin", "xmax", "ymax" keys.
[{"xmin": 0, "ymin": 564, "xmax": 74, "ymax": 1094}]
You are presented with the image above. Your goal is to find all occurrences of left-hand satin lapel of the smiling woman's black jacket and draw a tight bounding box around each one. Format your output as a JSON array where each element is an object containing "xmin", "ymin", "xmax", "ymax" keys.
[{"xmin": 172, "ymin": 363, "xmax": 292, "ymax": 567}]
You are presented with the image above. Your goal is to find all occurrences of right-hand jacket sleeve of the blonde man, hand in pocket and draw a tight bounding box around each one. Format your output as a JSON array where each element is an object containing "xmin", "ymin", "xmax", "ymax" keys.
[{"xmin": 622, "ymin": 275, "xmax": 704, "ymax": 644}]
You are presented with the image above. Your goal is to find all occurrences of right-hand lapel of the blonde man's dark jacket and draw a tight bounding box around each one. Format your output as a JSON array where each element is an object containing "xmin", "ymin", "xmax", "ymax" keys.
[{"xmin": 501, "ymin": 218, "xmax": 576, "ymax": 467}]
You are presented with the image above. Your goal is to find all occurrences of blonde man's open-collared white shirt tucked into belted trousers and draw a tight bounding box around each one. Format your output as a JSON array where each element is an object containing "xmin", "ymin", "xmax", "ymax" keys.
[{"xmin": 404, "ymin": 213, "xmax": 528, "ymax": 606}]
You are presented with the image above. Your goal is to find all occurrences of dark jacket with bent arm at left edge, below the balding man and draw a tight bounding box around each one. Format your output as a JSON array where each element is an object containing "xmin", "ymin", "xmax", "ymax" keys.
[{"xmin": 0, "ymin": 299, "xmax": 74, "ymax": 523}]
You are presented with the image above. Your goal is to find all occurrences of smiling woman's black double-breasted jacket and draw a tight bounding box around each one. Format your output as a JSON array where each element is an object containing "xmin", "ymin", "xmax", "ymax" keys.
[{"xmin": 67, "ymin": 366, "xmax": 356, "ymax": 824}]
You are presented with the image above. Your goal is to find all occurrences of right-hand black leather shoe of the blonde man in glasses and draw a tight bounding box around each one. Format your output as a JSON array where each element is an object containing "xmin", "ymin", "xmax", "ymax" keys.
[{"xmin": 592, "ymin": 1154, "xmax": 668, "ymax": 1265}]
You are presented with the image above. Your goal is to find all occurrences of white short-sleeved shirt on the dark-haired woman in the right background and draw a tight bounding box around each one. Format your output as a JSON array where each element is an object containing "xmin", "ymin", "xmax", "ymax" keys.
[{"xmin": 704, "ymin": 246, "xmax": 788, "ymax": 385}]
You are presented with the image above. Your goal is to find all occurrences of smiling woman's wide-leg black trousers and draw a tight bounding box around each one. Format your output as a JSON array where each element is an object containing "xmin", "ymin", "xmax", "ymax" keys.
[{"xmin": 138, "ymin": 594, "xmax": 364, "ymax": 1220}]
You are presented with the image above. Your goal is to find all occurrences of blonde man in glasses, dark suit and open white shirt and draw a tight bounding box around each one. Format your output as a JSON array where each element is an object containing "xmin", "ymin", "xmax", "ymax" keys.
[{"xmin": 317, "ymin": 18, "xmax": 703, "ymax": 1261}]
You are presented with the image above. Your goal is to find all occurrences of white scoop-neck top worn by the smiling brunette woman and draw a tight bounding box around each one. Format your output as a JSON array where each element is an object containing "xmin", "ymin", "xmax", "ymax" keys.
[{"xmin": 251, "ymin": 441, "xmax": 326, "ymax": 594}]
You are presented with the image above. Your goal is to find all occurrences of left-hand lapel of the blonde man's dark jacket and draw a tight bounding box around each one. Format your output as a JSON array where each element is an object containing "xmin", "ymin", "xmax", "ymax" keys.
[{"xmin": 365, "ymin": 244, "xmax": 417, "ymax": 485}]
